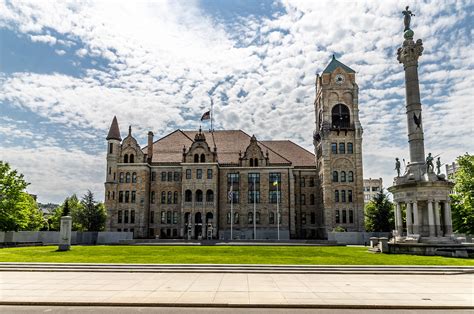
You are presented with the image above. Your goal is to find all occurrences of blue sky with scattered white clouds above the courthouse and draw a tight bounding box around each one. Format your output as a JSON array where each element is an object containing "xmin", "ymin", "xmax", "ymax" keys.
[{"xmin": 0, "ymin": 0, "xmax": 474, "ymax": 203}]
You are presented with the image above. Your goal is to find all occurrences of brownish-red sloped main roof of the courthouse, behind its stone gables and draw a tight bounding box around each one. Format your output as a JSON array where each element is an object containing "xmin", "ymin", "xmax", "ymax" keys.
[{"xmin": 142, "ymin": 130, "xmax": 315, "ymax": 167}]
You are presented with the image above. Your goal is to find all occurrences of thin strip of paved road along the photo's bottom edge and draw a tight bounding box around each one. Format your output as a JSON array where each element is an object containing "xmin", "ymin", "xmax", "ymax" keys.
[{"xmin": 0, "ymin": 306, "xmax": 472, "ymax": 314}]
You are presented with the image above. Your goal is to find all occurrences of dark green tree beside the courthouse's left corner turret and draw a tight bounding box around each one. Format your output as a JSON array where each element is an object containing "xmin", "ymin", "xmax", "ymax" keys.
[{"xmin": 77, "ymin": 191, "xmax": 106, "ymax": 231}]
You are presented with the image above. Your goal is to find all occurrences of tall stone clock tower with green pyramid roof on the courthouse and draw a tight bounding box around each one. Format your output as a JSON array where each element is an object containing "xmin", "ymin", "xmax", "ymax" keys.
[{"xmin": 314, "ymin": 56, "xmax": 364, "ymax": 236}]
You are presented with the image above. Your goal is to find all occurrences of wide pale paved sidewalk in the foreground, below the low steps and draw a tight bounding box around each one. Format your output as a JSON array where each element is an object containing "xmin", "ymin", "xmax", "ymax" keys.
[{"xmin": 0, "ymin": 271, "xmax": 474, "ymax": 308}]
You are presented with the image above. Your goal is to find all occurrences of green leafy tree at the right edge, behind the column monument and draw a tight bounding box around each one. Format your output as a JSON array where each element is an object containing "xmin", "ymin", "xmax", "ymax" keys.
[{"xmin": 451, "ymin": 153, "xmax": 474, "ymax": 234}]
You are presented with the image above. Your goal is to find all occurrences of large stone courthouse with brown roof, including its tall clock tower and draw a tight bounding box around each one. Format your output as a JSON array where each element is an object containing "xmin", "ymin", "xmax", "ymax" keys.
[{"xmin": 105, "ymin": 57, "xmax": 364, "ymax": 240}]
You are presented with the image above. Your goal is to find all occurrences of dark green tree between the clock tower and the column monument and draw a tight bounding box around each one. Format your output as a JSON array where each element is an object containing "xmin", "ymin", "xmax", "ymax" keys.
[{"xmin": 365, "ymin": 189, "xmax": 395, "ymax": 232}]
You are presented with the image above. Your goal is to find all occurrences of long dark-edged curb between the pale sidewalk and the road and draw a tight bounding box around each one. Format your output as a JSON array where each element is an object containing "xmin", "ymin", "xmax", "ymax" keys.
[{"xmin": 0, "ymin": 301, "xmax": 474, "ymax": 310}]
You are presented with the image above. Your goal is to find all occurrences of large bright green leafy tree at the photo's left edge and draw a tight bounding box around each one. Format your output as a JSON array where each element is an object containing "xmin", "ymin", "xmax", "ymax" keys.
[{"xmin": 0, "ymin": 161, "xmax": 45, "ymax": 231}]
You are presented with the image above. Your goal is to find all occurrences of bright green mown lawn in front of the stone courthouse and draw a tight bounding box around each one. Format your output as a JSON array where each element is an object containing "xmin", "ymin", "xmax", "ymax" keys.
[{"xmin": 0, "ymin": 246, "xmax": 474, "ymax": 266}]
